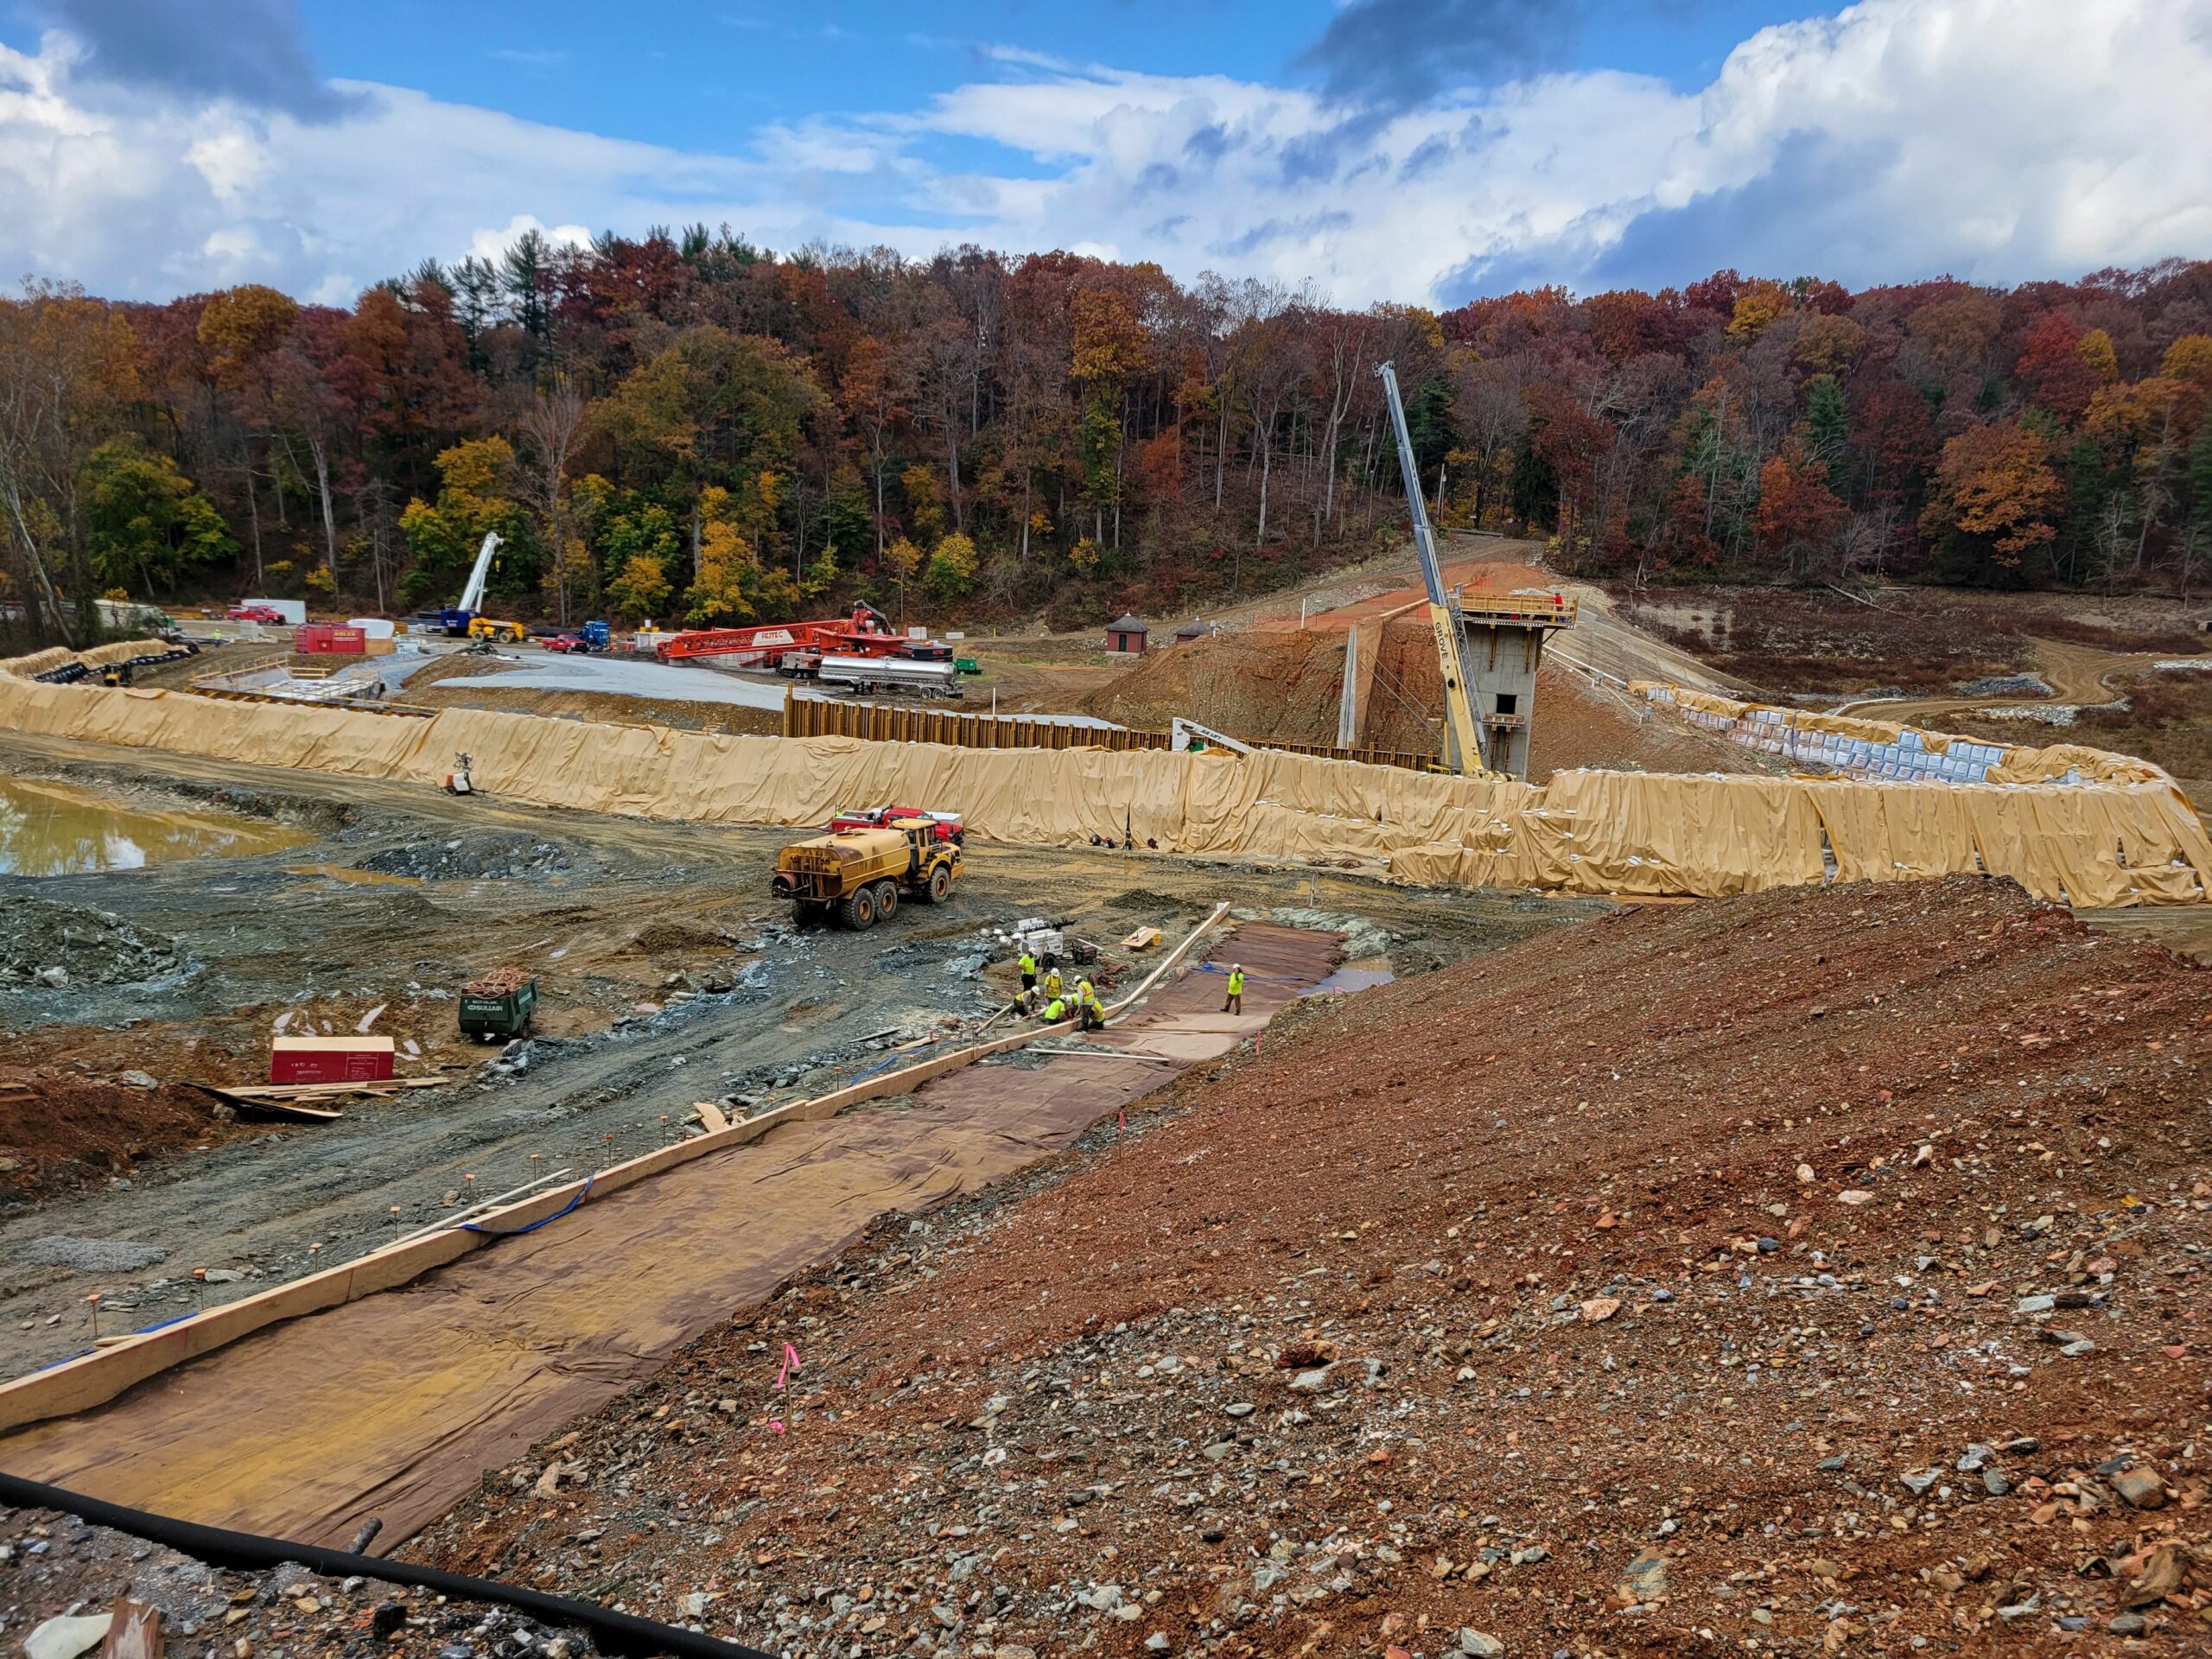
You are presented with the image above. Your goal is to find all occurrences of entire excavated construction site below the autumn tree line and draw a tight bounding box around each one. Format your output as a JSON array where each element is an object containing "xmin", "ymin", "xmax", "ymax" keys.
[{"xmin": 0, "ymin": 431, "xmax": 2212, "ymax": 1659}]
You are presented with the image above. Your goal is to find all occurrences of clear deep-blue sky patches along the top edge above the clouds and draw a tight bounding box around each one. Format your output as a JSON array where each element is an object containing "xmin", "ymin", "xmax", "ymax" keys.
[{"xmin": 289, "ymin": 0, "xmax": 1834, "ymax": 150}]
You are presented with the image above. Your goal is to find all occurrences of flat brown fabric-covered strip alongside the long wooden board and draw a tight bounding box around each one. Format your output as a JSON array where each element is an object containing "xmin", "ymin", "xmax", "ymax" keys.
[{"xmin": 0, "ymin": 923, "xmax": 1340, "ymax": 1546}]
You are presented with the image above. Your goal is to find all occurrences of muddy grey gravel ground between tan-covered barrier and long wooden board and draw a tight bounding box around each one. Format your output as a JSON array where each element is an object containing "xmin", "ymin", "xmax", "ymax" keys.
[{"xmin": 0, "ymin": 736, "xmax": 1606, "ymax": 1374}]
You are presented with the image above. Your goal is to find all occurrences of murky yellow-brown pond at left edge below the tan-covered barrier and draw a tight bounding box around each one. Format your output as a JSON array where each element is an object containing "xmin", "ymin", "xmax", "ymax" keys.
[{"xmin": 0, "ymin": 779, "xmax": 315, "ymax": 876}]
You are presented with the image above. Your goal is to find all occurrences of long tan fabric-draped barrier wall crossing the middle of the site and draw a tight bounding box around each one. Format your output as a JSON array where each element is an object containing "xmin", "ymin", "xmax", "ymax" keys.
[{"xmin": 13, "ymin": 679, "xmax": 2212, "ymax": 907}]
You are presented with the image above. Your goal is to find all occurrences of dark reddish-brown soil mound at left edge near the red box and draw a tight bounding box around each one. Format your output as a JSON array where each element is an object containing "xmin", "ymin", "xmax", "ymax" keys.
[{"xmin": 0, "ymin": 1066, "xmax": 244, "ymax": 1199}]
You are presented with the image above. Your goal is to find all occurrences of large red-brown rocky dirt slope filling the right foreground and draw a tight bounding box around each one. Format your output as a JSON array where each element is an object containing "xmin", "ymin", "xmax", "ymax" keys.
[{"xmin": 420, "ymin": 878, "xmax": 2212, "ymax": 1656}]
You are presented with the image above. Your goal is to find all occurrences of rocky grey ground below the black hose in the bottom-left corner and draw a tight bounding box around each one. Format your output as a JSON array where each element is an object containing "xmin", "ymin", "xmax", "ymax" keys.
[{"xmin": 0, "ymin": 1509, "xmax": 595, "ymax": 1659}]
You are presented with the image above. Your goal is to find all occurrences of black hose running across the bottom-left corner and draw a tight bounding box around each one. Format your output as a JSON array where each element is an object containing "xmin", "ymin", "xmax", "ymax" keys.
[{"xmin": 0, "ymin": 1473, "xmax": 774, "ymax": 1659}]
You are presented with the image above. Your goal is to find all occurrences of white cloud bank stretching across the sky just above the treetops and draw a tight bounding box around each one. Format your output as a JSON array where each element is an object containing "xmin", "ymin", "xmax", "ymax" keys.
[{"xmin": 0, "ymin": 0, "xmax": 2212, "ymax": 303}]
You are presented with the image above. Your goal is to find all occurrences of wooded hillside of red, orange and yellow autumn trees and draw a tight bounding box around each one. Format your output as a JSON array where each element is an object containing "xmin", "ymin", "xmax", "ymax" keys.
[{"xmin": 0, "ymin": 228, "xmax": 2212, "ymax": 639}]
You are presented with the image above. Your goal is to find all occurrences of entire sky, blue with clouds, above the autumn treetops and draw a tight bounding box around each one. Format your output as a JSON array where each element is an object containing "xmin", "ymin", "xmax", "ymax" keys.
[{"xmin": 0, "ymin": 0, "xmax": 2212, "ymax": 305}]
